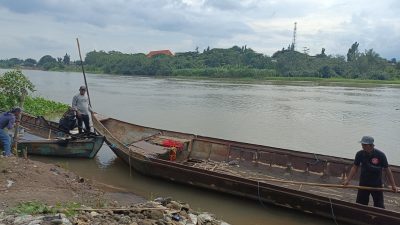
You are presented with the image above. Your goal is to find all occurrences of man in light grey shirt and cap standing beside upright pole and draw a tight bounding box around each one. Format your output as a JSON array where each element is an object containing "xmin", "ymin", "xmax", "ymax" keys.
[{"xmin": 72, "ymin": 86, "xmax": 92, "ymax": 134}]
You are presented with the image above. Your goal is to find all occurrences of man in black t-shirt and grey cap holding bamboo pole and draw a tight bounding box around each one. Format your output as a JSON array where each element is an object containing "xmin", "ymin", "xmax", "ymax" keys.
[{"xmin": 343, "ymin": 136, "xmax": 397, "ymax": 208}]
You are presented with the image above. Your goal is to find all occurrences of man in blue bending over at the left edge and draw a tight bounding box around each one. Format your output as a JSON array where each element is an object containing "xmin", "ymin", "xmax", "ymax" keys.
[{"xmin": 0, "ymin": 107, "xmax": 22, "ymax": 157}]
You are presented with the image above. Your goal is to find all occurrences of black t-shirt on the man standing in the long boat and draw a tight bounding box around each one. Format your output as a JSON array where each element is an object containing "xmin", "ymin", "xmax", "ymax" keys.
[{"xmin": 354, "ymin": 148, "xmax": 389, "ymax": 187}]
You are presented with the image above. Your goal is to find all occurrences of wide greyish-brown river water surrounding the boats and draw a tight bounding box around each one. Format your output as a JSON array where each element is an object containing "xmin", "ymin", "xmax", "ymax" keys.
[{"xmin": 0, "ymin": 70, "xmax": 400, "ymax": 225}]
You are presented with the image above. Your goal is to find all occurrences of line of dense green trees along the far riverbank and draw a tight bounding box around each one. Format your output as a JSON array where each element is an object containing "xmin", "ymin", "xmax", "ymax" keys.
[{"xmin": 0, "ymin": 42, "xmax": 400, "ymax": 80}]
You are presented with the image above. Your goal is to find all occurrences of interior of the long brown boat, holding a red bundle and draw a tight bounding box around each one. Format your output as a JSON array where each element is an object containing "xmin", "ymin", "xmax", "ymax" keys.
[{"xmin": 100, "ymin": 118, "xmax": 400, "ymax": 211}]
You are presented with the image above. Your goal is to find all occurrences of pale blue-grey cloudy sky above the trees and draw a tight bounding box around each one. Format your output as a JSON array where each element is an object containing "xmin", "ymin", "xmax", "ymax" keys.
[{"xmin": 0, "ymin": 0, "xmax": 400, "ymax": 59}]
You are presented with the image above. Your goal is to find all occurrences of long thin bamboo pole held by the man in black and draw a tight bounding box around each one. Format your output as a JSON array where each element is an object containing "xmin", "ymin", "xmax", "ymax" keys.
[{"xmin": 249, "ymin": 177, "xmax": 399, "ymax": 192}]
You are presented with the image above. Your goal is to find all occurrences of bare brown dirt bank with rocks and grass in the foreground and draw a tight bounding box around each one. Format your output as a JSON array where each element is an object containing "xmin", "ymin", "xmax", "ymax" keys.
[{"xmin": 0, "ymin": 156, "xmax": 228, "ymax": 225}]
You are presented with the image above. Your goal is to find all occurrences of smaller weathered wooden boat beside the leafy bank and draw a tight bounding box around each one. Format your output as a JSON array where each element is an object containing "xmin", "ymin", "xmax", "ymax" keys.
[{"xmin": 18, "ymin": 113, "xmax": 104, "ymax": 158}]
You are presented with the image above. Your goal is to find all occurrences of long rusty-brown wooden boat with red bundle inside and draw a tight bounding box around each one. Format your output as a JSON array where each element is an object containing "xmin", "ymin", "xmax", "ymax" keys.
[{"xmin": 93, "ymin": 114, "xmax": 400, "ymax": 225}]
